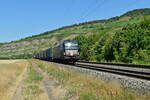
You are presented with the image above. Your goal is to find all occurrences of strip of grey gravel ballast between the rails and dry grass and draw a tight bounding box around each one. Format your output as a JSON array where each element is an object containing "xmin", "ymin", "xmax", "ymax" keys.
[{"xmin": 55, "ymin": 63, "xmax": 150, "ymax": 91}]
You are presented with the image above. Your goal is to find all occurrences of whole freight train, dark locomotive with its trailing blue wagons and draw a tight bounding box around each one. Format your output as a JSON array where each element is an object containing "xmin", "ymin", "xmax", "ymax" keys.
[{"xmin": 34, "ymin": 40, "xmax": 80, "ymax": 63}]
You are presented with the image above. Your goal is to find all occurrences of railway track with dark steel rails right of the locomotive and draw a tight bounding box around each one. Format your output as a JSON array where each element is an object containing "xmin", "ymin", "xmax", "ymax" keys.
[{"xmin": 75, "ymin": 61, "xmax": 150, "ymax": 81}]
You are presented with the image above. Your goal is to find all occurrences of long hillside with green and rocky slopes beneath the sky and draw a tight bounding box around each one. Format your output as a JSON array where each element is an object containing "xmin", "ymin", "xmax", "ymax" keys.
[{"xmin": 0, "ymin": 8, "xmax": 150, "ymax": 65}]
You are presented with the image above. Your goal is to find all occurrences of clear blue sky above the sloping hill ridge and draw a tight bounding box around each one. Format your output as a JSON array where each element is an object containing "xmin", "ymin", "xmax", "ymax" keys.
[{"xmin": 0, "ymin": 0, "xmax": 150, "ymax": 42}]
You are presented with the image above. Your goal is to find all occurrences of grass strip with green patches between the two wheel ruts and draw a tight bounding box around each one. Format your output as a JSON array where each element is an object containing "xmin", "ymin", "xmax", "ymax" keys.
[{"xmin": 21, "ymin": 61, "xmax": 48, "ymax": 100}]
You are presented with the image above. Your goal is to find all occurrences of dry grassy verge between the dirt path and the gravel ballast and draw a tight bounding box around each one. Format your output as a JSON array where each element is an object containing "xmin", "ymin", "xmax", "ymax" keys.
[{"xmin": 34, "ymin": 60, "xmax": 150, "ymax": 100}]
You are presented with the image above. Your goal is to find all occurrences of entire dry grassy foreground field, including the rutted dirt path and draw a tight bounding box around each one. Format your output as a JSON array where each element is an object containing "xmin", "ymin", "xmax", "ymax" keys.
[{"xmin": 0, "ymin": 60, "xmax": 150, "ymax": 100}]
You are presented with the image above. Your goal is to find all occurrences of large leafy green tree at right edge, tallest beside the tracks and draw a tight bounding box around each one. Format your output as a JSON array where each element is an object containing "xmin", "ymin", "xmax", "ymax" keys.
[{"xmin": 113, "ymin": 17, "xmax": 150, "ymax": 63}]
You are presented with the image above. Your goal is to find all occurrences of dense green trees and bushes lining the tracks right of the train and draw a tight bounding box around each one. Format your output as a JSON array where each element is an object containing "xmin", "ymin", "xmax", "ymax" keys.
[{"xmin": 75, "ymin": 16, "xmax": 150, "ymax": 64}]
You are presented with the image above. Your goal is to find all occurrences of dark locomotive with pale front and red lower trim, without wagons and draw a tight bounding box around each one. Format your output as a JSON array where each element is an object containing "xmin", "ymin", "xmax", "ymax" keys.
[{"xmin": 52, "ymin": 40, "xmax": 80, "ymax": 63}]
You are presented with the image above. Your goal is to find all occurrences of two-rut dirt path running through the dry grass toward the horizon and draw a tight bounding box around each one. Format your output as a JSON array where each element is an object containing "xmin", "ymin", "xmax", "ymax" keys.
[{"xmin": 4, "ymin": 62, "xmax": 65, "ymax": 100}]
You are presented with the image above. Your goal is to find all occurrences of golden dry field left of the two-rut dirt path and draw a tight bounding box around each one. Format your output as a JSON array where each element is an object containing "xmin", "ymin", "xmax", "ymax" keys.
[{"xmin": 0, "ymin": 60, "xmax": 27, "ymax": 100}]
